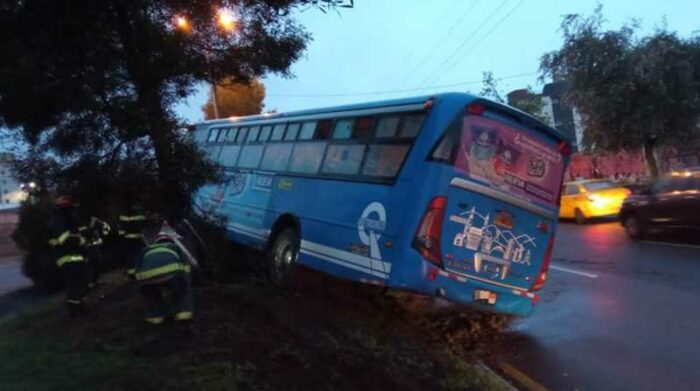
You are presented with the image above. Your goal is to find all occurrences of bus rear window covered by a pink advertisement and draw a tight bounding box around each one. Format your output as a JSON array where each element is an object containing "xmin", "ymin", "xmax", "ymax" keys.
[{"xmin": 455, "ymin": 116, "xmax": 564, "ymax": 205}]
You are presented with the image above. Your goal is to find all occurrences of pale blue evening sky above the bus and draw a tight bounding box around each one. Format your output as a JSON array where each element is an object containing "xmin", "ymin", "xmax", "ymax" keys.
[{"xmin": 176, "ymin": 0, "xmax": 700, "ymax": 123}]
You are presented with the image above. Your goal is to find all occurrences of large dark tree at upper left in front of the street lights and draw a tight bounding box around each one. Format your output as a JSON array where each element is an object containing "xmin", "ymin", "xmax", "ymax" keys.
[{"xmin": 0, "ymin": 0, "xmax": 352, "ymax": 219}]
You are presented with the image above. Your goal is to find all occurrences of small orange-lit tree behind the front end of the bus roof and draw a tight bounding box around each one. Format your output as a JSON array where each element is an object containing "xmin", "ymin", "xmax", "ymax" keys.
[{"xmin": 202, "ymin": 79, "xmax": 265, "ymax": 119}]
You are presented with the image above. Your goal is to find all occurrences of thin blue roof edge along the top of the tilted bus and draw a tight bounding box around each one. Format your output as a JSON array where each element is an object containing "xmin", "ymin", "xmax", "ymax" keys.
[{"xmin": 200, "ymin": 92, "xmax": 571, "ymax": 142}]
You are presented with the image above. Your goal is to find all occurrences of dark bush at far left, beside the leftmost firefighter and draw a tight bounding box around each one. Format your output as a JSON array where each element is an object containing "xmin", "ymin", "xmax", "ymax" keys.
[{"xmin": 12, "ymin": 199, "xmax": 63, "ymax": 290}]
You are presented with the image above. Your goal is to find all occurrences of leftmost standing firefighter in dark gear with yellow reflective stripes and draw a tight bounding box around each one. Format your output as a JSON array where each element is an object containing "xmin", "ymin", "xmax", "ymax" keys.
[{"xmin": 49, "ymin": 195, "xmax": 88, "ymax": 317}]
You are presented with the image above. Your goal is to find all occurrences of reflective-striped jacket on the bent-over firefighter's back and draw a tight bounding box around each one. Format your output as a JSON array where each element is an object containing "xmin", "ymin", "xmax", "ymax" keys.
[{"xmin": 135, "ymin": 243, "xmax": 190, "ymax": 284}]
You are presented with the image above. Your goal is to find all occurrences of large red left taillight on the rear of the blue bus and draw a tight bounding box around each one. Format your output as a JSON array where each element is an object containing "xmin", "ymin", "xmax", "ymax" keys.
[{"xmin": 413, "ymin": 197, "xmax": 447, "ymax": 266}]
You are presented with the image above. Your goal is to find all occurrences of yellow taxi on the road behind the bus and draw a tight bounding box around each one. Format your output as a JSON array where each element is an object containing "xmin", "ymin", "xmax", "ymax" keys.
[{"xmin": 559, "ymin": 179, "xmax": 631, "ymax": 224}]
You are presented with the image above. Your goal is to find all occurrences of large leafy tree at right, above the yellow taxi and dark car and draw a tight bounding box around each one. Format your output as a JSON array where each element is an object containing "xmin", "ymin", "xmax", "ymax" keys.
[{"xmin": 540, "ymin": 7, "xmax": 700, "ymax": 176}]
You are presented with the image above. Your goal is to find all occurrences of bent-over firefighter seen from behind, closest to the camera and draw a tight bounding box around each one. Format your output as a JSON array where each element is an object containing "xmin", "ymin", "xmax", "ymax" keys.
[{"xmin": 134, "ymin": 225, "xmax": 196, "ymax": 324}]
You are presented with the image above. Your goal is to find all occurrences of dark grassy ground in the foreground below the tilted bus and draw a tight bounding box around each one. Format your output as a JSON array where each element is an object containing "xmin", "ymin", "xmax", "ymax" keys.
[{"xmin": 0, "ymin": 272, "xmax": 516, "ymax": 391}]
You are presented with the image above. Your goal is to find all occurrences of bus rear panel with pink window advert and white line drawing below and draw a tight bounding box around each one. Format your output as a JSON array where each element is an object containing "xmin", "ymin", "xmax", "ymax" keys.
[{"xmin": 440, "ymin": 110, "xmax": 565, "ymax": 294}]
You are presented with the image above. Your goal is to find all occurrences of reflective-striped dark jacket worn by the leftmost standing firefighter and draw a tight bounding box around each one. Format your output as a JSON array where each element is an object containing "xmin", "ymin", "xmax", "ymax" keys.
[{"xmin": 49, "ymin": 208, "xmax": 86, "ymax": 267}]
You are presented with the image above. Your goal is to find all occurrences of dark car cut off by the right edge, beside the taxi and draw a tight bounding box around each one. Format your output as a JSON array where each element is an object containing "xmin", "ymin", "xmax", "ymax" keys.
[{"xmin": 620, "ymin": 170, "xmax": 700, "ymax": 239}]
